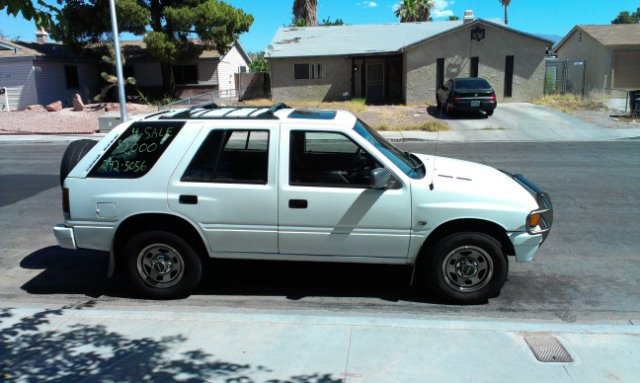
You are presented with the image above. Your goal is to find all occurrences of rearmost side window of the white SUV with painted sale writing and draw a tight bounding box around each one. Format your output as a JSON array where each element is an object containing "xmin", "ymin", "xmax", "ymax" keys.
[{"xmin": 89, "ymin": 121, "xmax": 185, "ymax": 178}]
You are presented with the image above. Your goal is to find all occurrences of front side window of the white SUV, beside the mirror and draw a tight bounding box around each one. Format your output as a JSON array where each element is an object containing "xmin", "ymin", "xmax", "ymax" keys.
[{"xmin": 289, "ymin": 131, "xmax": 382, "ymax": 188}]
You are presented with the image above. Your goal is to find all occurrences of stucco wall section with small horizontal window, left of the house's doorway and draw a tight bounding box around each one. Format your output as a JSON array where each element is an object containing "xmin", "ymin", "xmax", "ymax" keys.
[{"xmin": 269, "ymin": 56, "xmax": 351, "ymax": 101}]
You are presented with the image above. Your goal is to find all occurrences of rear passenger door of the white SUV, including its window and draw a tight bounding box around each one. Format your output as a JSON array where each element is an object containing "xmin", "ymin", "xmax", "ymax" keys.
[{"xmin": 168, "ymin": 121, "xmax": 278, "ymax": 257}]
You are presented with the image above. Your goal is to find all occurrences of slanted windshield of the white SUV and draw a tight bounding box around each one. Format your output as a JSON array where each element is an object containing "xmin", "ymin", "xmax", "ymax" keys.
[{"xmin": 353, "ymin": 120, "xmax": 425, "ymax": 179}]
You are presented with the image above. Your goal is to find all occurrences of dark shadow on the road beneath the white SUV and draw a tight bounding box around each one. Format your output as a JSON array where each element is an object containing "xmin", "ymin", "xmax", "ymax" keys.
[{"xmin": 20, "ymin": 246, "xmax": 444, "ymax": 304}]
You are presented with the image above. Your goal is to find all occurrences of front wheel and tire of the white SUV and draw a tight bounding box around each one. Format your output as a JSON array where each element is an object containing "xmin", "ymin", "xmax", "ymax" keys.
[{"xmin": 425, "ymin": 232, "xmax": 509, "ymax": 304}]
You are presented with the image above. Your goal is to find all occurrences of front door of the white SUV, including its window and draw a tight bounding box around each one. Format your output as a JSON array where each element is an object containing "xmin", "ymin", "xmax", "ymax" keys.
[{"xmin": 278, "ymin": 126, "xmax": 411, "ymax": 262}]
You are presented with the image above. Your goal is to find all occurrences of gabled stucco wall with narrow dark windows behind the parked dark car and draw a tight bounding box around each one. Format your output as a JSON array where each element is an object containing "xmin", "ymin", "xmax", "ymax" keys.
[{"xmin": 404, "ymin": 24, "xmax": 547, "ymax": 104}]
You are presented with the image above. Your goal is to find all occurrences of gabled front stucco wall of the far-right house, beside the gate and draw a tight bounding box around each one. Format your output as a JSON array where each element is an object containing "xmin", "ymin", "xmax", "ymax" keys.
[{"xmin": 557, "ymin": 29, "xmax": 612, "ymax": 88}]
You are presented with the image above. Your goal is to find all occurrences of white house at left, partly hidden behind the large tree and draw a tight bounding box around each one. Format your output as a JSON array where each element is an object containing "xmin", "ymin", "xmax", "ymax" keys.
[{"xmin": 0, "ymin": 30, "xmax": 251, "ymax": 110}]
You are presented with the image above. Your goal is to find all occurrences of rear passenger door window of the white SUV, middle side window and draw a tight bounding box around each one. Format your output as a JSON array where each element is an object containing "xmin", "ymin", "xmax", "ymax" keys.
[{"xmin": 181, "ymin": 130, "xmax": 269, "ymax": 185}]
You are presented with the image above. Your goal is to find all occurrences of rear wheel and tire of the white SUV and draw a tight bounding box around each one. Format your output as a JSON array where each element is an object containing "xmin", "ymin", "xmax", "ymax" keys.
[{"xmin": 123, "ymin": 231, "xmax": 202, "ymax": 299}]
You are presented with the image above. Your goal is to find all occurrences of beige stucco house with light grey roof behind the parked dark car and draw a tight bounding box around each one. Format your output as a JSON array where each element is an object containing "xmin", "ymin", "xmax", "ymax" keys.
[{"xmin": 267, "ymin": 11, "xmax": 552, "ymax": 104}]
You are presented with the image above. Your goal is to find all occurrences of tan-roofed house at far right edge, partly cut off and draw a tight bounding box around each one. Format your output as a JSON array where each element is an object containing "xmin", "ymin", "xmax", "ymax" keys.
[{"xmin": 554, "ymin": 24, "xmax": 640, "ymax": 90}]
